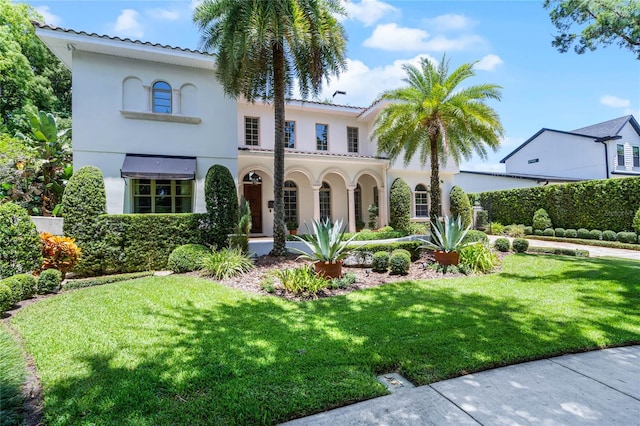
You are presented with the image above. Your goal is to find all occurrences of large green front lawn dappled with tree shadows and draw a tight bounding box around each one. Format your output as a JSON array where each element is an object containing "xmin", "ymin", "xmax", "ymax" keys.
[{"xmin": 12, "ymin": 255, "xmax": 640, "ymax": 425}]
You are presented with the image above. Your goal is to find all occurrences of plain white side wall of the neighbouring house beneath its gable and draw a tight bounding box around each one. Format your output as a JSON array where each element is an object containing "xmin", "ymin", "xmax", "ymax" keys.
[{"xmin": 505, "ymin": 130, "xmax": 610, "ymax": 179}]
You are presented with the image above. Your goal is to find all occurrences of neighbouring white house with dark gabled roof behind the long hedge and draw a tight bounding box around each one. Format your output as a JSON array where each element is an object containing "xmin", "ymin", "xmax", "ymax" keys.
[{"xmin": 500, "ymin": 115, "xmax": 640, "ymax": 180}]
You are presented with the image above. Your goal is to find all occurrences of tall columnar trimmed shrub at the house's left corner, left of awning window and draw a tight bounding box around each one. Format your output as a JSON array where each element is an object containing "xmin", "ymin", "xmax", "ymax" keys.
[{"xmin": 62, "ymin": 166, "xmax": 106, "ymax": 275}]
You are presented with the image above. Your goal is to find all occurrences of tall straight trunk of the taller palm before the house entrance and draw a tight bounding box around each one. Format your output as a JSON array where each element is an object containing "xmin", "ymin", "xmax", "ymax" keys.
[{"xmin": 270, "ymin": 43, "xmax": 287, "ymax": 256}]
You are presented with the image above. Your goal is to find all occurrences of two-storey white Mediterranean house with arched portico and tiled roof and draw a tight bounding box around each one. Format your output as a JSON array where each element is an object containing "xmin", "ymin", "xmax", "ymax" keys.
[{"xmin": 34, "ymin": 22, "xmax": 459, "ymax": 235}]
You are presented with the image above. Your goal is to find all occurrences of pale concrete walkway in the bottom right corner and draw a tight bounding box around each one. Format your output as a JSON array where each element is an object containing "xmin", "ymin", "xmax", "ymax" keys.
[{"xmin": 285, "ymin": 346, "xmax": 640, "ymax": 426}]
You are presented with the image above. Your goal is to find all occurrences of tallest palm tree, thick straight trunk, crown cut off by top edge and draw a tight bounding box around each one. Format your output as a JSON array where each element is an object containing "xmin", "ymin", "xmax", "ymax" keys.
[{"xmin": 193, "ymin": 0, "xmax": 346, "ymax": 255}]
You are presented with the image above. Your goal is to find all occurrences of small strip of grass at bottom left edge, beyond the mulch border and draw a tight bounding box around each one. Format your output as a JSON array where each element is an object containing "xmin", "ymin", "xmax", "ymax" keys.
[{"xmin": 0, "ymin": 323, "xmax": 26, "ymax": 426}]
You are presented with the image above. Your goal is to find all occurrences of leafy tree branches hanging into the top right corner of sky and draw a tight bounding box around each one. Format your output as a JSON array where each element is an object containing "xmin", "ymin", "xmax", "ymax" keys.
[{"xmin": 544, "ymin": 0, "xmax": 640, "ymax": 59}]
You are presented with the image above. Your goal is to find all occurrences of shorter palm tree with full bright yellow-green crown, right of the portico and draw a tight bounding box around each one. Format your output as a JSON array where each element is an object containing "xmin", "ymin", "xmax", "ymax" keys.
[{"xmin": 373, "ymin": 55, "xmax": 503, "ymax": 219}]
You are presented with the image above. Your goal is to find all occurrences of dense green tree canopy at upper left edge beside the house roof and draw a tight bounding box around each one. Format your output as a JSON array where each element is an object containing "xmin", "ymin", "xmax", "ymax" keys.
[{"xmin": 0, "ymin": 0, "xmax": 71, "ymax": 135}]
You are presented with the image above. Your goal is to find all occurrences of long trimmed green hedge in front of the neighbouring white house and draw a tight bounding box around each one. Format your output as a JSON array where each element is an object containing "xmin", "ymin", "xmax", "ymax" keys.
[{"xmin": 479, "ymin": 178, "xmax": 640, "ymax": 232}]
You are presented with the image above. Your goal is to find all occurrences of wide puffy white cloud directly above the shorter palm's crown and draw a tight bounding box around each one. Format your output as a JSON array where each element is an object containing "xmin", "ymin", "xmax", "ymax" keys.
[{"xmin": 364, "ymin": 23, "xmax": 484, "ymax": 52}]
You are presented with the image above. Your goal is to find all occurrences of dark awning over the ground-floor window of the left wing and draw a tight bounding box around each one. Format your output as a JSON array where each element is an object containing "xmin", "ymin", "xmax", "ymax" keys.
[{"xmin": 120, "ymin": 154, "xmax": 196, "ymax": 180}]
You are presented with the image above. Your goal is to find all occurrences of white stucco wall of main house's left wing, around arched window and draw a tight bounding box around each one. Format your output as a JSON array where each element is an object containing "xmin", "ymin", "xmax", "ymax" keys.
[{"xmin": 73, "ymin": 51, "xmax": 237, "ymax": 213}]
